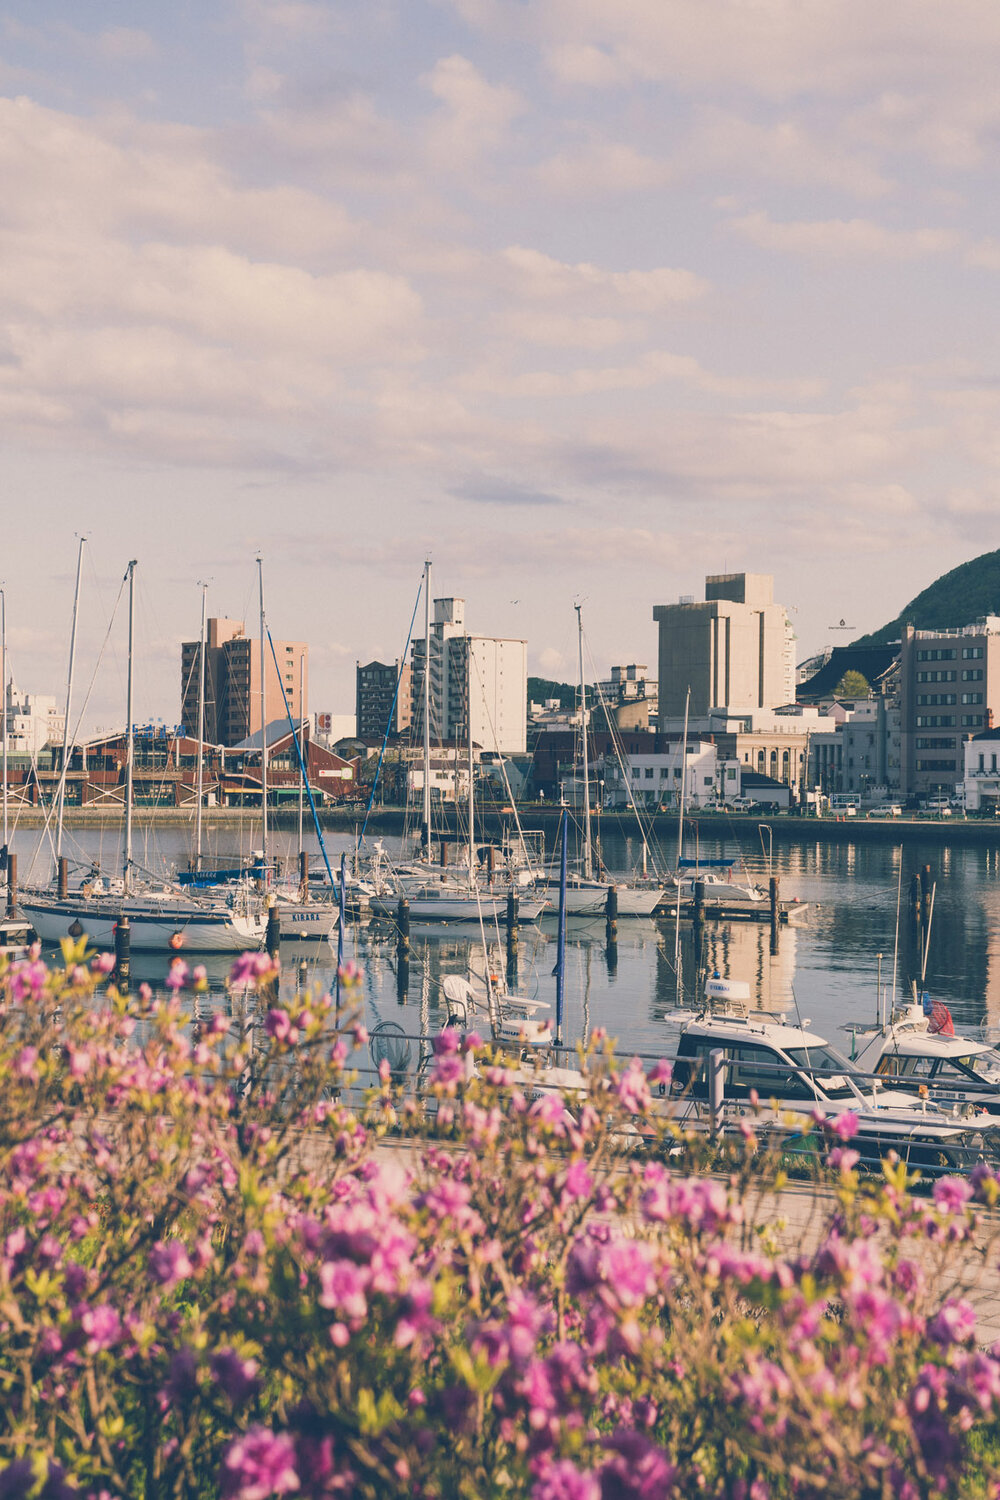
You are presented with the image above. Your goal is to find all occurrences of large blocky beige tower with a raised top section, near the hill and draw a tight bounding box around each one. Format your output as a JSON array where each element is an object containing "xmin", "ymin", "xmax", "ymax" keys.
[{"xmin": 652, "ymin": 573, "xmax": 795, "ymax": 725}]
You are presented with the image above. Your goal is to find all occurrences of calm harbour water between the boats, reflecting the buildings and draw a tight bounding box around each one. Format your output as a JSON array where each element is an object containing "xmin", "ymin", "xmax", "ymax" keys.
[{"xmin": 13, "ymin": 815, "xmax": 1000, "ymax": 1055}]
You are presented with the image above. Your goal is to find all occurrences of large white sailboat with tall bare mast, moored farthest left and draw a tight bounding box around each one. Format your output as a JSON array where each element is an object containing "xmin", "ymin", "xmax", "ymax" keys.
[{"xmin": 19, "ymin": 560, "xmax": 265, "ymax": 953}]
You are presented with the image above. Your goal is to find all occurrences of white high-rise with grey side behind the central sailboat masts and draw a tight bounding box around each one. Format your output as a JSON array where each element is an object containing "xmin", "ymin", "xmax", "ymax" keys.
[{"xmin": 411, "ymin": 599, "xmax": 528, "ymax": 755}]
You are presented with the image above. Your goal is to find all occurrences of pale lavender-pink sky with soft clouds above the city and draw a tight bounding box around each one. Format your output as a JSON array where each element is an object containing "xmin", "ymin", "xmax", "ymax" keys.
[{"xmin": 0, "ymin": 0, "xmax": 1000, "ymax": 729}]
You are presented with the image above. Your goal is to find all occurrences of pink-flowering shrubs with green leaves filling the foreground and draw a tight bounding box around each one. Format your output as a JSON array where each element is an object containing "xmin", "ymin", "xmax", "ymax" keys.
[{"xmin": 0, "ymin": 948, "xmax": 1000, "ymax": 1500}]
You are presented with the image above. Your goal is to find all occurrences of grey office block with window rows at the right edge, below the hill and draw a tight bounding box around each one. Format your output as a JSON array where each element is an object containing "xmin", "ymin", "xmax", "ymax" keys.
[{"xmin": 900, "ymin": 615, "xmax": 1000, "ymax": 797}]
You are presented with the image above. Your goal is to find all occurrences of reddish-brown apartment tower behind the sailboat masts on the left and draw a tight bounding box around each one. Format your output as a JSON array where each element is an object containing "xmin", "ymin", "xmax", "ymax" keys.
[{"xmin": 180, "ymin": 620, "xmax": 309, "ymax": 746}]
